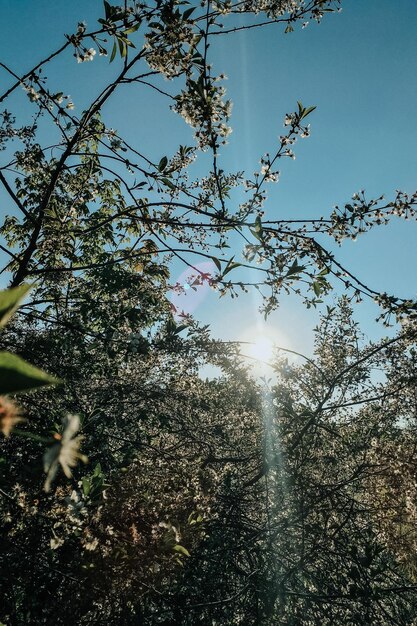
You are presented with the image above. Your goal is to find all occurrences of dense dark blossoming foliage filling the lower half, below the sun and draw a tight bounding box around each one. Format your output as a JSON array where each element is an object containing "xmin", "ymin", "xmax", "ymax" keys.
[{"xmin": 2, "ymin": 301, "xmax": 417, "ymax": 626}]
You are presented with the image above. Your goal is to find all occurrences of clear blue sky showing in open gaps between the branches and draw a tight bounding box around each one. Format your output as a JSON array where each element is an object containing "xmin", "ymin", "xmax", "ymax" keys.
[{"xmin": 0, "ymin": 0, "xmax": 417, "ymax": 351}]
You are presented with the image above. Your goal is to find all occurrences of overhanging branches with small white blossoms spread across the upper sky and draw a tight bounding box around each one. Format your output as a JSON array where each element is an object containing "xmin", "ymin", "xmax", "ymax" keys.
[{"xmin": 0, "ymin": 0, "xmax": 416, "ymax": 319}]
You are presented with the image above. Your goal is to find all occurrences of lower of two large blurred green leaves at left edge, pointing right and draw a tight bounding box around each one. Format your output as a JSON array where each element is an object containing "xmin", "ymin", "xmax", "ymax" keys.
[{"xmin": 0, "ymin": 352, "xmax": 61, "ymax": 394}]
